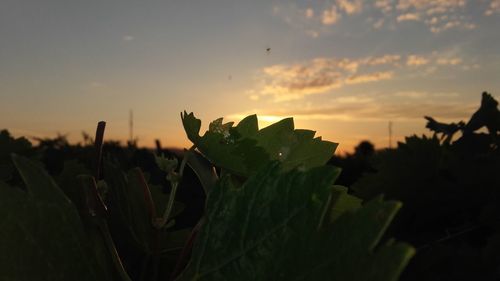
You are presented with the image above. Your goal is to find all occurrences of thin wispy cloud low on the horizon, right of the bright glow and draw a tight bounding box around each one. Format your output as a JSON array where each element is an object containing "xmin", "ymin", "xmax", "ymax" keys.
[{"xmin": 228, "ymin": 92, "xmax": 478, "ymax": 122}]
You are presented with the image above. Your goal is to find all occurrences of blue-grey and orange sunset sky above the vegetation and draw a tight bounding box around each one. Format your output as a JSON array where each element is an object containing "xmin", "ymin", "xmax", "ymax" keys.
[{"xmin": 0, "ymin": 0, "xmax": 500, "ymax": 152}]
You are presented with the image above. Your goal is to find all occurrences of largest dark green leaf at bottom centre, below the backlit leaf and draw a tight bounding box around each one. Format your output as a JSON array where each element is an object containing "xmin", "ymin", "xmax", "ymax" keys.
[{"xmin": 178, "ymin": 162, "xmax": 414, "ymax": 281}]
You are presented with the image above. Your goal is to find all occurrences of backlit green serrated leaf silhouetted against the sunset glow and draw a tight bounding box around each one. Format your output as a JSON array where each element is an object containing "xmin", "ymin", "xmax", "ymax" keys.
[{"xmin": 181, "ymin": 112, "xmax": 337, "ymax": 177}]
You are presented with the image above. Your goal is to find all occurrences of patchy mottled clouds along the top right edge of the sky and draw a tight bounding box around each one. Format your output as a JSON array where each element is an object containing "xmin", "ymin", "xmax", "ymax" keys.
[{"xmin": 274, "ymin": 0, "xmax": 500, "ymax": 38}]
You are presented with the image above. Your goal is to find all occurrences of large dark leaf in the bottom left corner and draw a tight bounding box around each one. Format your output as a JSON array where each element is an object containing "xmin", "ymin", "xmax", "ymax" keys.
[{"xmin": 0, "ymin": 156, "xmax": 112, "ymax": 280}]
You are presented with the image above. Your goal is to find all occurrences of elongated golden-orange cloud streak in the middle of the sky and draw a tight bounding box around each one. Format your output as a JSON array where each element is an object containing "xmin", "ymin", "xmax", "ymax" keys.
[{"xmin": 252, "ymin": 48, "xmax": 473, "ymax": 102}]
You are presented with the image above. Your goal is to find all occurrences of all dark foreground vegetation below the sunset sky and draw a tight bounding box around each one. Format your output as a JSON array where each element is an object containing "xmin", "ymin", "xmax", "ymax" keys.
[{"xmin": 0, "ymin": 93, "xmax": 500, "ymax": 281}]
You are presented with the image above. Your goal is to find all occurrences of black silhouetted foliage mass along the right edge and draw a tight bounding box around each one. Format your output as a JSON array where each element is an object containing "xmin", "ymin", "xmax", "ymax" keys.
[{"xmin": 352, "ymin": 92, "xmax": 500, "ymax": 280}]
